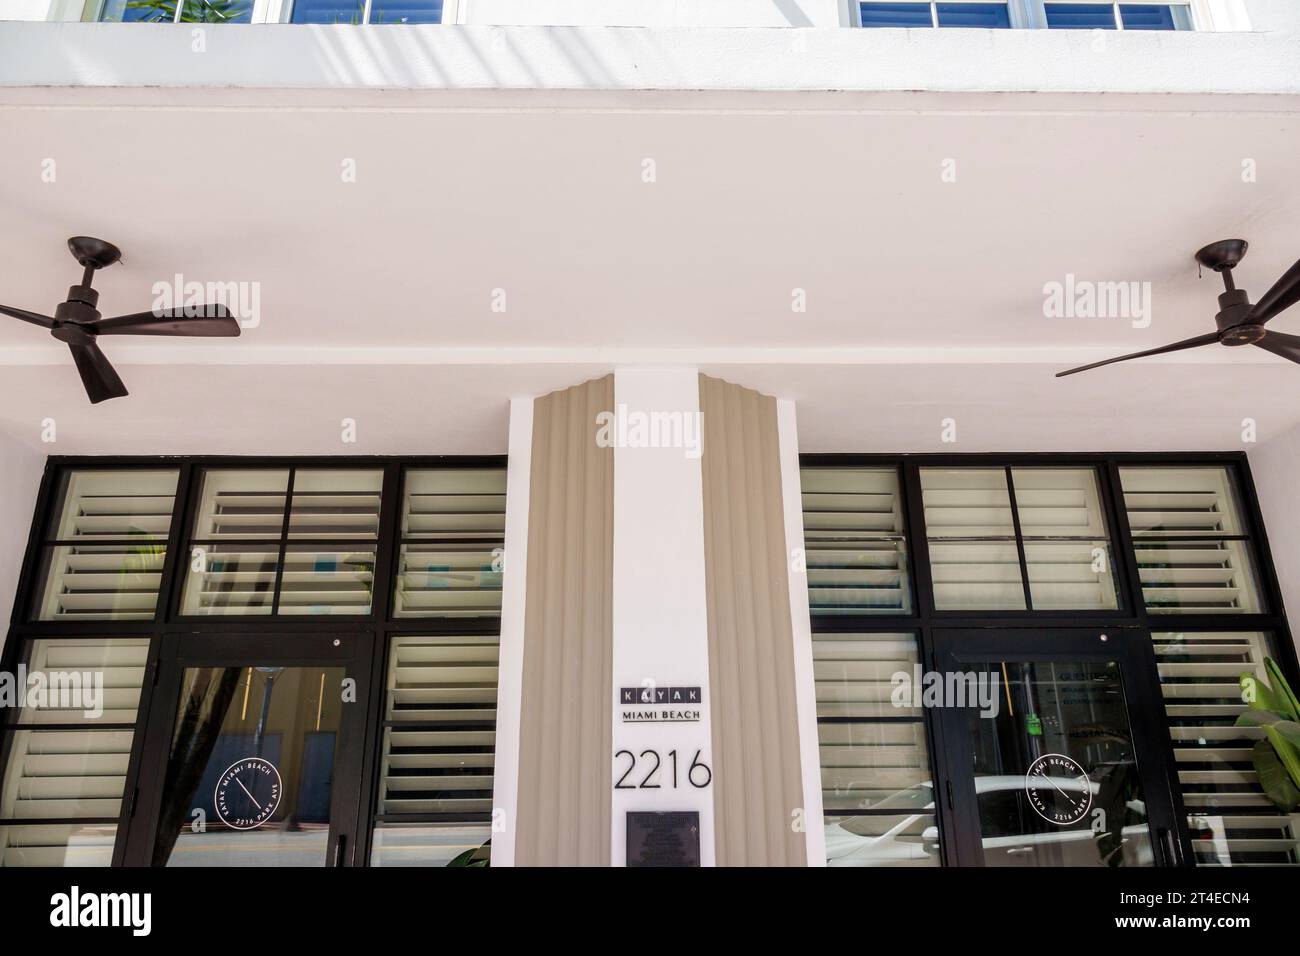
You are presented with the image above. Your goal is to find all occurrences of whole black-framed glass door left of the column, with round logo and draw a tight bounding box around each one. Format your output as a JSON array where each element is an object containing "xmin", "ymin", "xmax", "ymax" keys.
[{"xmin": 126, "ymin": 633, "xmax": 372, "ymax": 866}]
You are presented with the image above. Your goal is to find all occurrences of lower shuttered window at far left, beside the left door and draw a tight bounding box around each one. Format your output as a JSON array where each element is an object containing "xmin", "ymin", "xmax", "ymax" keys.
[{"xmin": 0, "ymin": 637, "xmax": 150, "ymax": 866}]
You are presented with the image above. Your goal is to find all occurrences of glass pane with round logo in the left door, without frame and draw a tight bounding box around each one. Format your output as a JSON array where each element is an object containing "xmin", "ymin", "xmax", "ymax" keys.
[{"xmin": 153, "ymin": 667, "xmax": 345, "ymax": 866}]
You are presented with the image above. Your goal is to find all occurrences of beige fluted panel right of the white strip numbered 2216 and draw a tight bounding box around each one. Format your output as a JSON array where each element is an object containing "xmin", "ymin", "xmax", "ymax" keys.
[{"xmin": 699, "ymin": 376, "xmax": 800, "ymax": 866}]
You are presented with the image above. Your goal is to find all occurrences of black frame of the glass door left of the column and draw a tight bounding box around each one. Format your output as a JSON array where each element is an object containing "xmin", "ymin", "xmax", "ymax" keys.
[{"xmin": 114, "ymin": 631, "xmax": 376, "ymax": 866}]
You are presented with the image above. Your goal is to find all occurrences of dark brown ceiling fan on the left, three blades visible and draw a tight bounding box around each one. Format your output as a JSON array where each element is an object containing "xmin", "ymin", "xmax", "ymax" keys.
[{"xmin": 0, "ymin": 235, "xmax": 239, "ymax": 405}]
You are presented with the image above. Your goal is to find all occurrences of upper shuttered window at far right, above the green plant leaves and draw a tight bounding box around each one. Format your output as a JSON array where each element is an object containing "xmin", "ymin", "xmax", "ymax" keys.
[{"xmin": 1119, "ymin": 467, "xmax": 1261, "ymax": 614}]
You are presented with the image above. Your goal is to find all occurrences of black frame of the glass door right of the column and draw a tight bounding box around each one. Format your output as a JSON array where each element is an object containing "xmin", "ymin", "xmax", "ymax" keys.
[{"xmin": 932, "ymin": 627, "xmax": 1192, "ymax": 866}]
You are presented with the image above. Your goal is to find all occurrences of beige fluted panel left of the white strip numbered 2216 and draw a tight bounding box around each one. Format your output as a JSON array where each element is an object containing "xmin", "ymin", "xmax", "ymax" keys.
[{"xmin": 515, "ymin": 376, "xmax": 614, "ymax": 866}]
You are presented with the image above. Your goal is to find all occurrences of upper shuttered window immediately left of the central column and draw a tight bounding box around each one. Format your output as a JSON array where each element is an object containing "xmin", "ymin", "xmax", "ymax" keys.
[{"xmin": 393, "ymin": 468, "xmax": 506, "ymax": 618}]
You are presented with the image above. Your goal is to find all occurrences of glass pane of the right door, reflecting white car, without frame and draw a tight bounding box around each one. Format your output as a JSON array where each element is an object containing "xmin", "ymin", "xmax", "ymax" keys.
[{"xmin": 970, "ymin": 661, "xmax": 1154, "ymax": 866}]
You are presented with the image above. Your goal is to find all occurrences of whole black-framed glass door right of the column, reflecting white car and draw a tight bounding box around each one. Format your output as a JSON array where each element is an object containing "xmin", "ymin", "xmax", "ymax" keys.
[{"xmin": 935, "ymin": 628, "xmax": 1184, "ymax": 866}]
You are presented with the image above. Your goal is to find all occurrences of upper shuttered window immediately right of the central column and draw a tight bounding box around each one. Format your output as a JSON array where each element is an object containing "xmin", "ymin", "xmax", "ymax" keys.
[{"xmin": 800, "ymin": 467, "xmax": 911, "ymax": 615}]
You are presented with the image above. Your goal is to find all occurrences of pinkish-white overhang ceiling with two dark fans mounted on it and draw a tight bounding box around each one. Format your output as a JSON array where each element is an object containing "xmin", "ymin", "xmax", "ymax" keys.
[{"xmin": 0, "ymin": 91, "xmax": 1300, "ymax": 454}]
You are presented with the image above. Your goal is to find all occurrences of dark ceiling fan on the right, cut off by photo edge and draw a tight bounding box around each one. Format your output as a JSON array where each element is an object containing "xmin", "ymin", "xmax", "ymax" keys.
[{"xmin": 1056, "ymin": 239, "xmax": 1300, "ymax": 378}]
